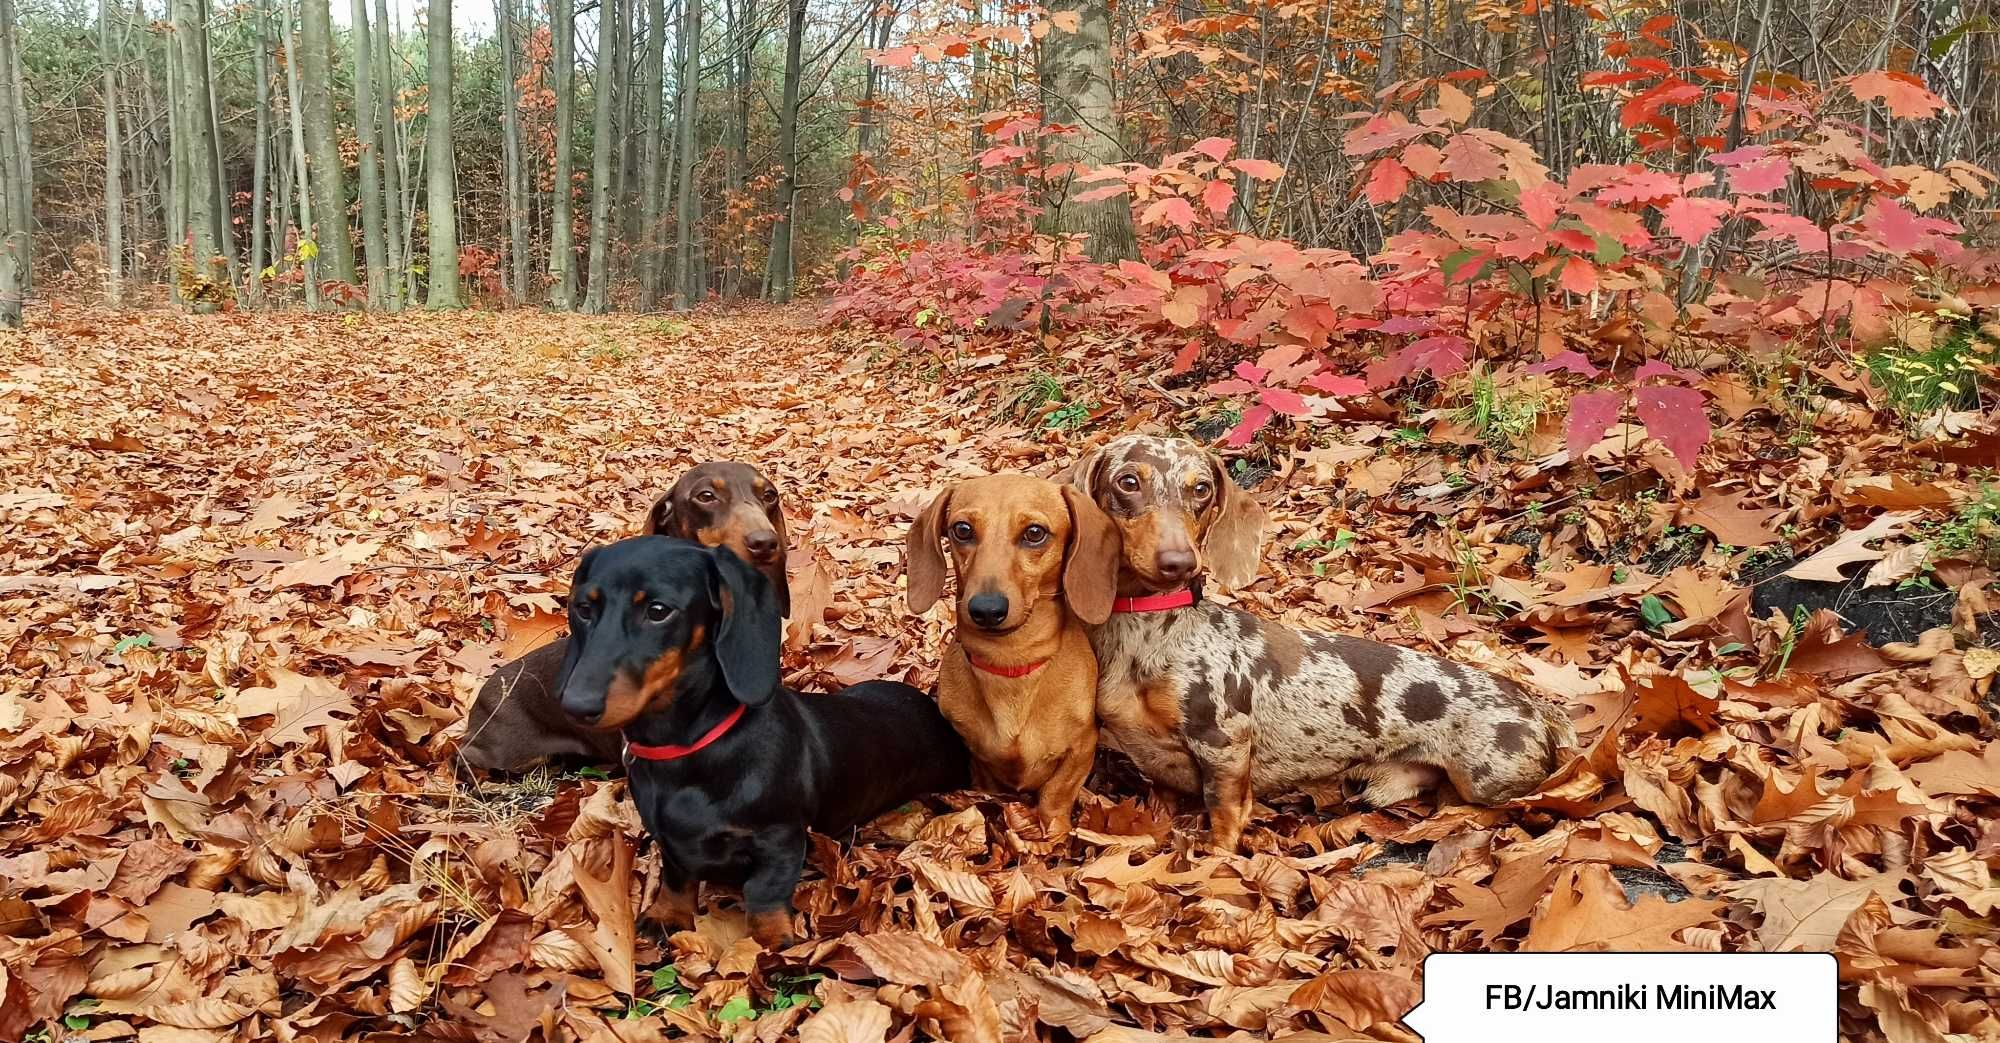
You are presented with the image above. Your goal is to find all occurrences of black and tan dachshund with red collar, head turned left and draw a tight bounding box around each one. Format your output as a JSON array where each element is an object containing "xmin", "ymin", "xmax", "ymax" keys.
[{"xmin": 562, "ymin": 535, "xmax": 970, "ymax": 947}]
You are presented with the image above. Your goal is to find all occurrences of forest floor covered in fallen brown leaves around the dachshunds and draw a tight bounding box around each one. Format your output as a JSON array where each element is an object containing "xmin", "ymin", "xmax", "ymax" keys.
[{"xmin": 0, "ymin": 310, "xmax": 2000, "ymax": 1043}]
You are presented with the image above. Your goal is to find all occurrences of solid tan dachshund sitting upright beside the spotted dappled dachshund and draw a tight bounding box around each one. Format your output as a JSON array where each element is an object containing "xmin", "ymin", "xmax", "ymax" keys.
[{"xmin": 908, "ymin": 474, "xmax": 1120, "ymax": 835}]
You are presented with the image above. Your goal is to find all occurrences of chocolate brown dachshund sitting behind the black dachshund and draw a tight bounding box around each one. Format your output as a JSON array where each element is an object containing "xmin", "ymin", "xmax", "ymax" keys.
[{"xmin": 458, "ymin": 460, "xmax": 792, "ymax": 771}]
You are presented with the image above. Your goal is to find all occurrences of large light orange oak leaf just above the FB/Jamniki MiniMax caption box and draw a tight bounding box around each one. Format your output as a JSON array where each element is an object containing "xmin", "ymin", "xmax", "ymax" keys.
[{"xmin": 1520, "ymin": 863, "xmax": 1726, "ymax": 953}]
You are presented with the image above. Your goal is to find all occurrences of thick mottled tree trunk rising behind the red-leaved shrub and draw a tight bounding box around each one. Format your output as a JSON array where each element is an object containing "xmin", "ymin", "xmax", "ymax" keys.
[{"xmin": 1040, "ymin": 0, "xmax": 1138, "ymax": 262}]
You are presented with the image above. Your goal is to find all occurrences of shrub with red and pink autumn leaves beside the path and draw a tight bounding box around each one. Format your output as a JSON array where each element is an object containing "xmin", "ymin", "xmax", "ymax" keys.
[{"xmin": 830, "ymin": 20, "xmax": 2000, "ymax": 468}]
